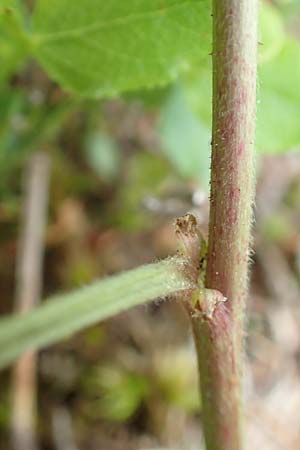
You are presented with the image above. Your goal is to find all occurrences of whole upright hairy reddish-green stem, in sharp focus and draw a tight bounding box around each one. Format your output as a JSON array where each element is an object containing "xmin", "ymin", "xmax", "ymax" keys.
[{"xmin": 193, "ymin": 0, "xmax": 258, "ymax": 450}]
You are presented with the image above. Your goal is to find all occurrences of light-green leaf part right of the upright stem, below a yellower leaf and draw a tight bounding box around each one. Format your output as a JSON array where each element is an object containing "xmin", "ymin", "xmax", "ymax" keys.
[{"xmin": 257, "ymin": 39, "xmax": 300, "ymax": 153}]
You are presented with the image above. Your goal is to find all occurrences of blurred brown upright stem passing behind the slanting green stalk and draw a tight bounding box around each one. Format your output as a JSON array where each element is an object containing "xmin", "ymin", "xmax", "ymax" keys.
[{"xmin": 12, "ymin": 153, "xmax": 50, "ymax": 450}]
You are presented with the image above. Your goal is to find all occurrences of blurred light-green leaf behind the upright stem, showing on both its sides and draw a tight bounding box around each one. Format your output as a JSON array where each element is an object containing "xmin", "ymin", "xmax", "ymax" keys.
[{"xmin": 183, "ymin": 36, "xmax": 300, "ymax": 154}]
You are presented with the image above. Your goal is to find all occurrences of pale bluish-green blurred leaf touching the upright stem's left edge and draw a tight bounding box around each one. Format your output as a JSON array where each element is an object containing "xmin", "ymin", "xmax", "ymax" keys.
[{"xmin": 159, "ymin": 86, "xmax": 210, "ymax": 187}]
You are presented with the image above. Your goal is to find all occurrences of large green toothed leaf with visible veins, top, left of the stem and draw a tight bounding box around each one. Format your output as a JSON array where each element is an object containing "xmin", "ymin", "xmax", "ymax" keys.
[{"xmin": 33, "ymin": 0, "xmax": 211, "ymax": 97}]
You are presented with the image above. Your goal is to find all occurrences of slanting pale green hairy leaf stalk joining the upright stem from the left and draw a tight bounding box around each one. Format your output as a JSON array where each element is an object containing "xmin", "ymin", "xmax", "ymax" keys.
[{"xmin": 0, "ymin": 257, "xmax": 194, "ymax": 368}]
